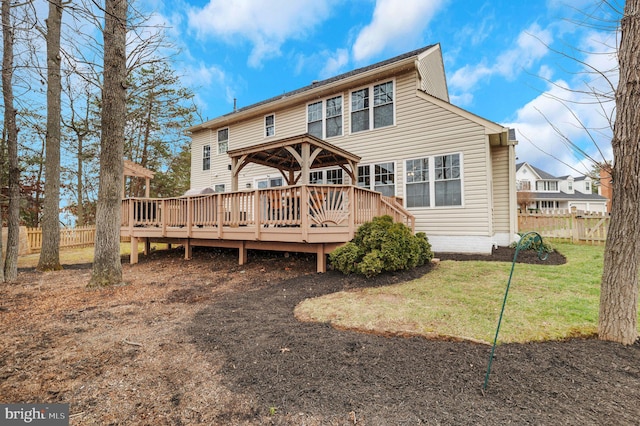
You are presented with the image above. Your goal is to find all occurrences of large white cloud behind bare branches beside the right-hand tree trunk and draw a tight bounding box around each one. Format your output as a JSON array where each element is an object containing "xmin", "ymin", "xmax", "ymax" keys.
[{"xmin": 505, "ymin": 26, "xmax": 617, "ymax": 175}]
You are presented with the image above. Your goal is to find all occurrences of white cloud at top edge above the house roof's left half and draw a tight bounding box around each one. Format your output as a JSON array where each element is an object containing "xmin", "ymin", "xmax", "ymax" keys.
[{"xmin": 188, "ymin": 0, "xmax": 332, "ymax": 67}]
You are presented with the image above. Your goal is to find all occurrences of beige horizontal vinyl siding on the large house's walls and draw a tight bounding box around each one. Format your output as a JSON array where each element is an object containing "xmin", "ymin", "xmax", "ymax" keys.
[{"xmin": 192, "ymin": 70, "xmax": 508, "ymax": 245}]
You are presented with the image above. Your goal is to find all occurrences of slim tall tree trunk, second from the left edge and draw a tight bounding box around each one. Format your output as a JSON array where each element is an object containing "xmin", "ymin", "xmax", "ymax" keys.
[{"xmin": 38, "ymin": 0, "xmax": 62, "ymax": 271}]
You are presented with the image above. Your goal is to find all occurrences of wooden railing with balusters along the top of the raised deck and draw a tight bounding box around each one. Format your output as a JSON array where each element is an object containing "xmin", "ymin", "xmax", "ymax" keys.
[{"xmin": 122, "ymin": 185, "xmax": 415, "ymax": 235}]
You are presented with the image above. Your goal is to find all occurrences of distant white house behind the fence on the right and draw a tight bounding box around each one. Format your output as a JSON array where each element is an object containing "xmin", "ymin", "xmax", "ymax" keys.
[{"xmin": 516, "ymin": 162, "xmax": 607, "ymax": 213}]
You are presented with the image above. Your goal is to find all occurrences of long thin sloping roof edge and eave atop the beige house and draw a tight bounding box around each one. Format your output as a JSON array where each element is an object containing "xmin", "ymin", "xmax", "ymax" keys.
[{"xmin": 187, "ymin": 44, "xmax": 439, "ymax": 132}]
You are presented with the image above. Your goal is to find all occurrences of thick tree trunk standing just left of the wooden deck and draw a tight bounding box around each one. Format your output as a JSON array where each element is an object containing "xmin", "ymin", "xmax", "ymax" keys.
[{"xmin": 88, "ymin": 0, "xmax": 127, "ymax": 287}]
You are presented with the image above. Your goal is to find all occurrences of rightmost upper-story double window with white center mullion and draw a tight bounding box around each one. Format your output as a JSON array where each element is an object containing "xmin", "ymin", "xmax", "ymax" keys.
[{"xmin": 351, "ymin": 81, "xmax": 394, "ymax": 133}]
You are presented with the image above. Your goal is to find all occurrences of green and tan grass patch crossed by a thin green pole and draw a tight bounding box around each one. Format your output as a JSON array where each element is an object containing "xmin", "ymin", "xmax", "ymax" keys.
[{"xmin": 296, "ymin": 243, "xmax": 636, "ymax": 343}]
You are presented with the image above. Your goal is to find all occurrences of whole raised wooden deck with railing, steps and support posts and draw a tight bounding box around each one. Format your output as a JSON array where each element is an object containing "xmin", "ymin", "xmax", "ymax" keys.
[{"xmin": 120, "ymin": 185, "xmax": 415, "ymax": 272}]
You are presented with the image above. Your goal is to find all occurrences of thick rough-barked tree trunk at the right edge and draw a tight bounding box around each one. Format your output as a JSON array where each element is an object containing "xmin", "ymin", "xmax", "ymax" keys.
[{"xmin": 598, "ymin": 0, "xmax": 640, "ymax": 345}]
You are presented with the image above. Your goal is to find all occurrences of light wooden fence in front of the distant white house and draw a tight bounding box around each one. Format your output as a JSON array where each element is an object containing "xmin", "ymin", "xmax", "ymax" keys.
[{"xmin": 518, "ymin": 210, "xmax": 610, "ymax": 244}]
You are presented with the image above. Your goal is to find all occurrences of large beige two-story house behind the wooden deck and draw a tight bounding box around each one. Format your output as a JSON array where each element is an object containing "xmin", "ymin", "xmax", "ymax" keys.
[{"xmin": 189, "ymin": 44, "xmax": 517, "ymax": 253}]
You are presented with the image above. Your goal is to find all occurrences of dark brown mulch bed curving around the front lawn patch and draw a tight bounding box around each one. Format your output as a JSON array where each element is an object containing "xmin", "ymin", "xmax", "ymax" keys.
[{"xmin": 189, "ymin": 249, "xmax": 640, "ymax": 425}]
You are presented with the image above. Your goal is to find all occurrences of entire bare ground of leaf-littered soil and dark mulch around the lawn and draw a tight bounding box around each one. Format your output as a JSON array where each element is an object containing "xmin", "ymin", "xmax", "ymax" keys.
[{"xmin": 0, "ymin": 245, "xmax": 640, "ymax": 425}]
